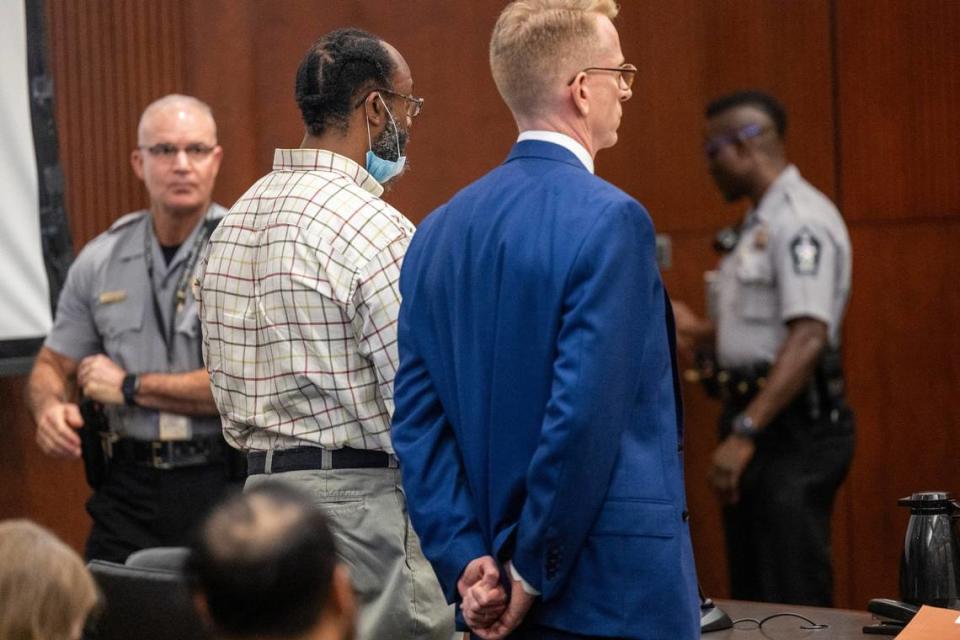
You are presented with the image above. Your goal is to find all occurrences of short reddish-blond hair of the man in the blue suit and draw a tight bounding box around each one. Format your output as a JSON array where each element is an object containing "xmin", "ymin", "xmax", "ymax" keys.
[{"xmin": 490, "ymin": 0, "xmax": 619, "ymax": 115}]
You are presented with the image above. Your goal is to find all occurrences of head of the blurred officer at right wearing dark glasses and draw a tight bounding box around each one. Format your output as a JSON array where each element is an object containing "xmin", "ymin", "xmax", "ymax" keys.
[{"xmin": 703, "ymin": 91, "xmax": 787, "ymax": 204}]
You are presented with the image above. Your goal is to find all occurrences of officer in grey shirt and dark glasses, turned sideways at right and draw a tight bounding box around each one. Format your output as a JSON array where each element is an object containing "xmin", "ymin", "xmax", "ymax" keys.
[{"xmin": 674, "ymin": 92, "xmax": 854, "ymax": 606}]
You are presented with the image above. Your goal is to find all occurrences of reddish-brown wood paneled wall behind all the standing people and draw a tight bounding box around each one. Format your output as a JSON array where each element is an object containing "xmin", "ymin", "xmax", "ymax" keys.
[{"xmin": 0, "ymin": 0, "xmax": 960, "ymax": 608}]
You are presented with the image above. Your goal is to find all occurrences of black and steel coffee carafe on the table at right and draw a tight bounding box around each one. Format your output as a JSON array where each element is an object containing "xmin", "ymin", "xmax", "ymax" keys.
[{"xmin": 897, "ymin": 491, "xmax": 960, "ymax": 609}]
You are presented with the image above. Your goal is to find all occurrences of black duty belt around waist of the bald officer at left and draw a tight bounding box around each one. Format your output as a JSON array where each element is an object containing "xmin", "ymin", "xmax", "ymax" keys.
[{"xmin": 106, "ymin": 435, "xmax": 229, "ymax": 469}]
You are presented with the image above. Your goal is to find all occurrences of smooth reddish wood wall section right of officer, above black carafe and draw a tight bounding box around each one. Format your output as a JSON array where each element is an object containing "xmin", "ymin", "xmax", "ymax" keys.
[{"xmin": 835, "ymin": 0, "xmax": 960, "ymax": 606}]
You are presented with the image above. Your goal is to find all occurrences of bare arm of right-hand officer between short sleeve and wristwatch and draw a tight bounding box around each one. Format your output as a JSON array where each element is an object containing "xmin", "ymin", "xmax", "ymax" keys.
[{"xmin": 744, "ymin": 318, "xmax": 827, "ymax": 429}]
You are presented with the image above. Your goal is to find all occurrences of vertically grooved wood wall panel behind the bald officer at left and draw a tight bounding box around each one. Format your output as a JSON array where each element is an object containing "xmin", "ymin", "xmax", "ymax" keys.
[{"xmin": 47, "ymin": 0, "xmax": 185, "ymax": 248}]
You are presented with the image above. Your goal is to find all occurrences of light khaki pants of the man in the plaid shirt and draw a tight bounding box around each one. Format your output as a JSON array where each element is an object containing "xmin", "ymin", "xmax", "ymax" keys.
[{"xmin": 246, "ymin": 469, "xmax": 454, "ymax": 640}]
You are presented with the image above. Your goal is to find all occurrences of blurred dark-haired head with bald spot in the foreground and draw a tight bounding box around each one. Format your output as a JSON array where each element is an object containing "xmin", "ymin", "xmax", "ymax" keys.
[{"xmin": 187, "ymin": 484, "xmax": 356, "ymax": 640}]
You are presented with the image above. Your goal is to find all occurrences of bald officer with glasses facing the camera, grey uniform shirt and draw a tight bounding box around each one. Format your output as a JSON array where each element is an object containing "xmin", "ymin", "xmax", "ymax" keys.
[{"xmin": 28, "ymin": 95, "xmax": 238, "ymax": 562}]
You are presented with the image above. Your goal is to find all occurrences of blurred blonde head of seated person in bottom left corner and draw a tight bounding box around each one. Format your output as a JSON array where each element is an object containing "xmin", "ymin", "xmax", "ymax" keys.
[{"xmin": 0, "ymin": 520, "xmax": 99, "ymax": 640}]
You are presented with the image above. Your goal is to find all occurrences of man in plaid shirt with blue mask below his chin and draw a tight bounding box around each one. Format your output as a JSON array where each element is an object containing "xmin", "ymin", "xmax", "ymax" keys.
[{"xmin": 197, "ymin": 29, "xmax": 453, "ymax": 639}]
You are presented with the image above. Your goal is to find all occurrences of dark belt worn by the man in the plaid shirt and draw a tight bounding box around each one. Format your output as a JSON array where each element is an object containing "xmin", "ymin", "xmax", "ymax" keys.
[{"xmin": 247, "ymin": 447, "xmax": 397, "ymax": 475}]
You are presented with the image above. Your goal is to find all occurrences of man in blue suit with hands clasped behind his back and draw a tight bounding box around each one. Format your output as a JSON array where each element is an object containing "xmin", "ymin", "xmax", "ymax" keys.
[{"xmin": 393, "ymin": 0, "xmax": 700, "ymax": 640}]
